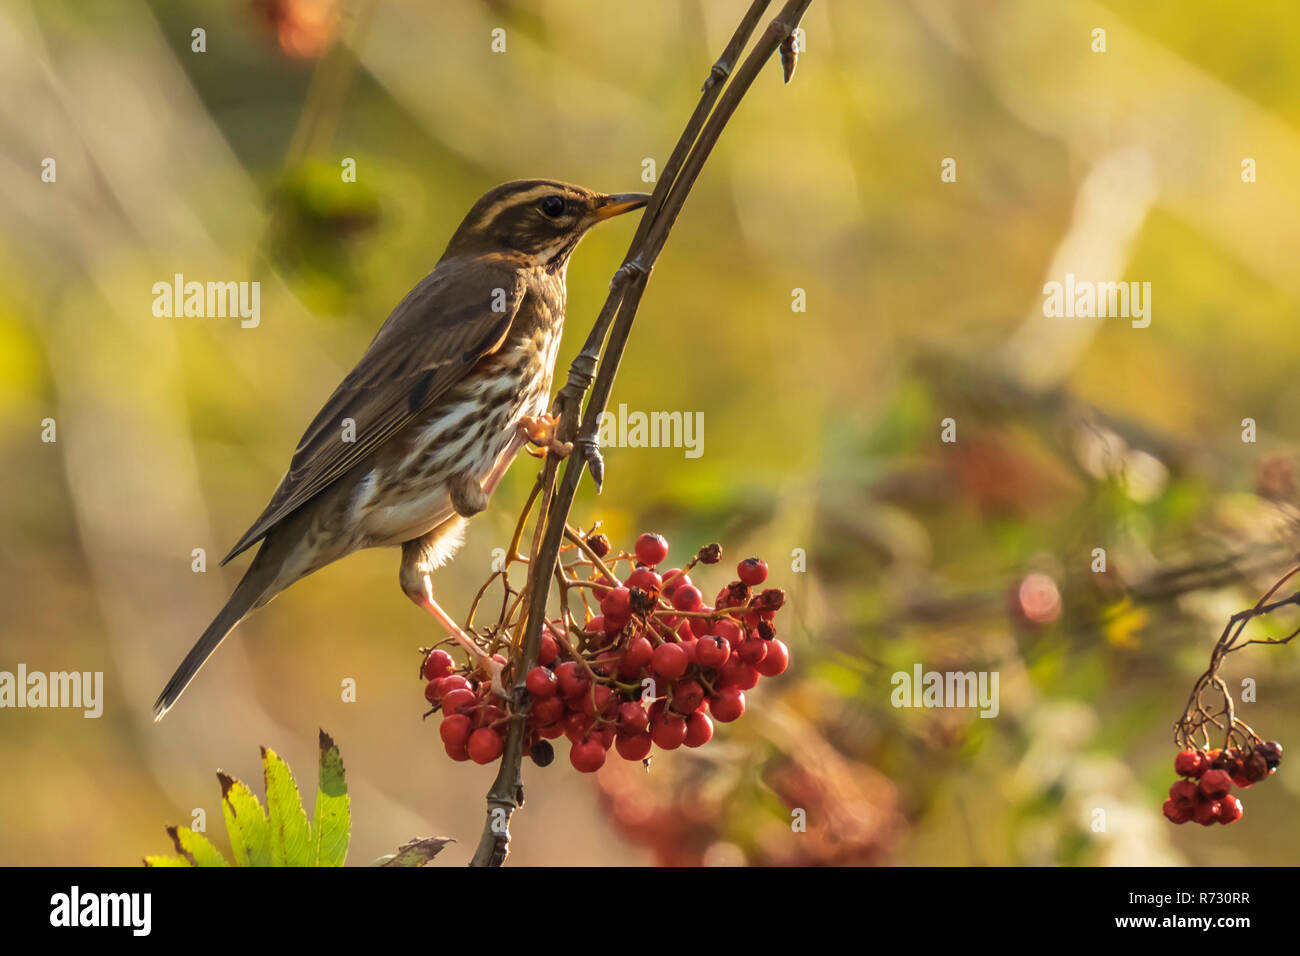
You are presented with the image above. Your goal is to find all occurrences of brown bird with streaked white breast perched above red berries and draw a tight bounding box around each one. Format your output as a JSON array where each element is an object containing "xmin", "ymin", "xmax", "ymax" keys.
[{"xmin": 153, "ymin": 179, "xmax": 650, "ymax": 721}]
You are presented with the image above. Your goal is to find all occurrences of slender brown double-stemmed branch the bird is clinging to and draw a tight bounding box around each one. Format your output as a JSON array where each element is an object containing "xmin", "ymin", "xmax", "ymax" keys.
[{"xmin": 471, "ymin": 0, "xmax": 813, "ymax": 866}]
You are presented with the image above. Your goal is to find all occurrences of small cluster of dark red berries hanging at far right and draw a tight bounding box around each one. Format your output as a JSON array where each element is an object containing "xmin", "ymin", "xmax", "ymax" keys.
[{"xmin": 1164, "ymin": 740, "xmax": 1282, "ymax": 826}]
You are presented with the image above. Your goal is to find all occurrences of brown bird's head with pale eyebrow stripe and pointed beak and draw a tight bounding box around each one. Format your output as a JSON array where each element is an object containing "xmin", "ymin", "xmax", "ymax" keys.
[{"xmin": 443, "ymin": 179, "xmax": 650, "ymax": 268}]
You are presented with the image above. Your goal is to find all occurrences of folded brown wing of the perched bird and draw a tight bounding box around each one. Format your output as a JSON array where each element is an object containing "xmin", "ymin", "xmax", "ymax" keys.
[{"xmin": 221, "ymin": 261, "xmax": 525, "ymax": 564}]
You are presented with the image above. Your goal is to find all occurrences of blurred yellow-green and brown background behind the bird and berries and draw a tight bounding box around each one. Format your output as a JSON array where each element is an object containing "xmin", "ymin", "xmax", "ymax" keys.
[{"xmin": 0, "ymin": 0, "xmax": 1300, "ymax": 865}]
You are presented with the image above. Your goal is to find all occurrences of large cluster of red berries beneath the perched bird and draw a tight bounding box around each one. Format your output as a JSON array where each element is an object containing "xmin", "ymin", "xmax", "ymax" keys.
[{"xmin": 421, "ymin": 533, "xmax": 790, "ymax": 773}]
